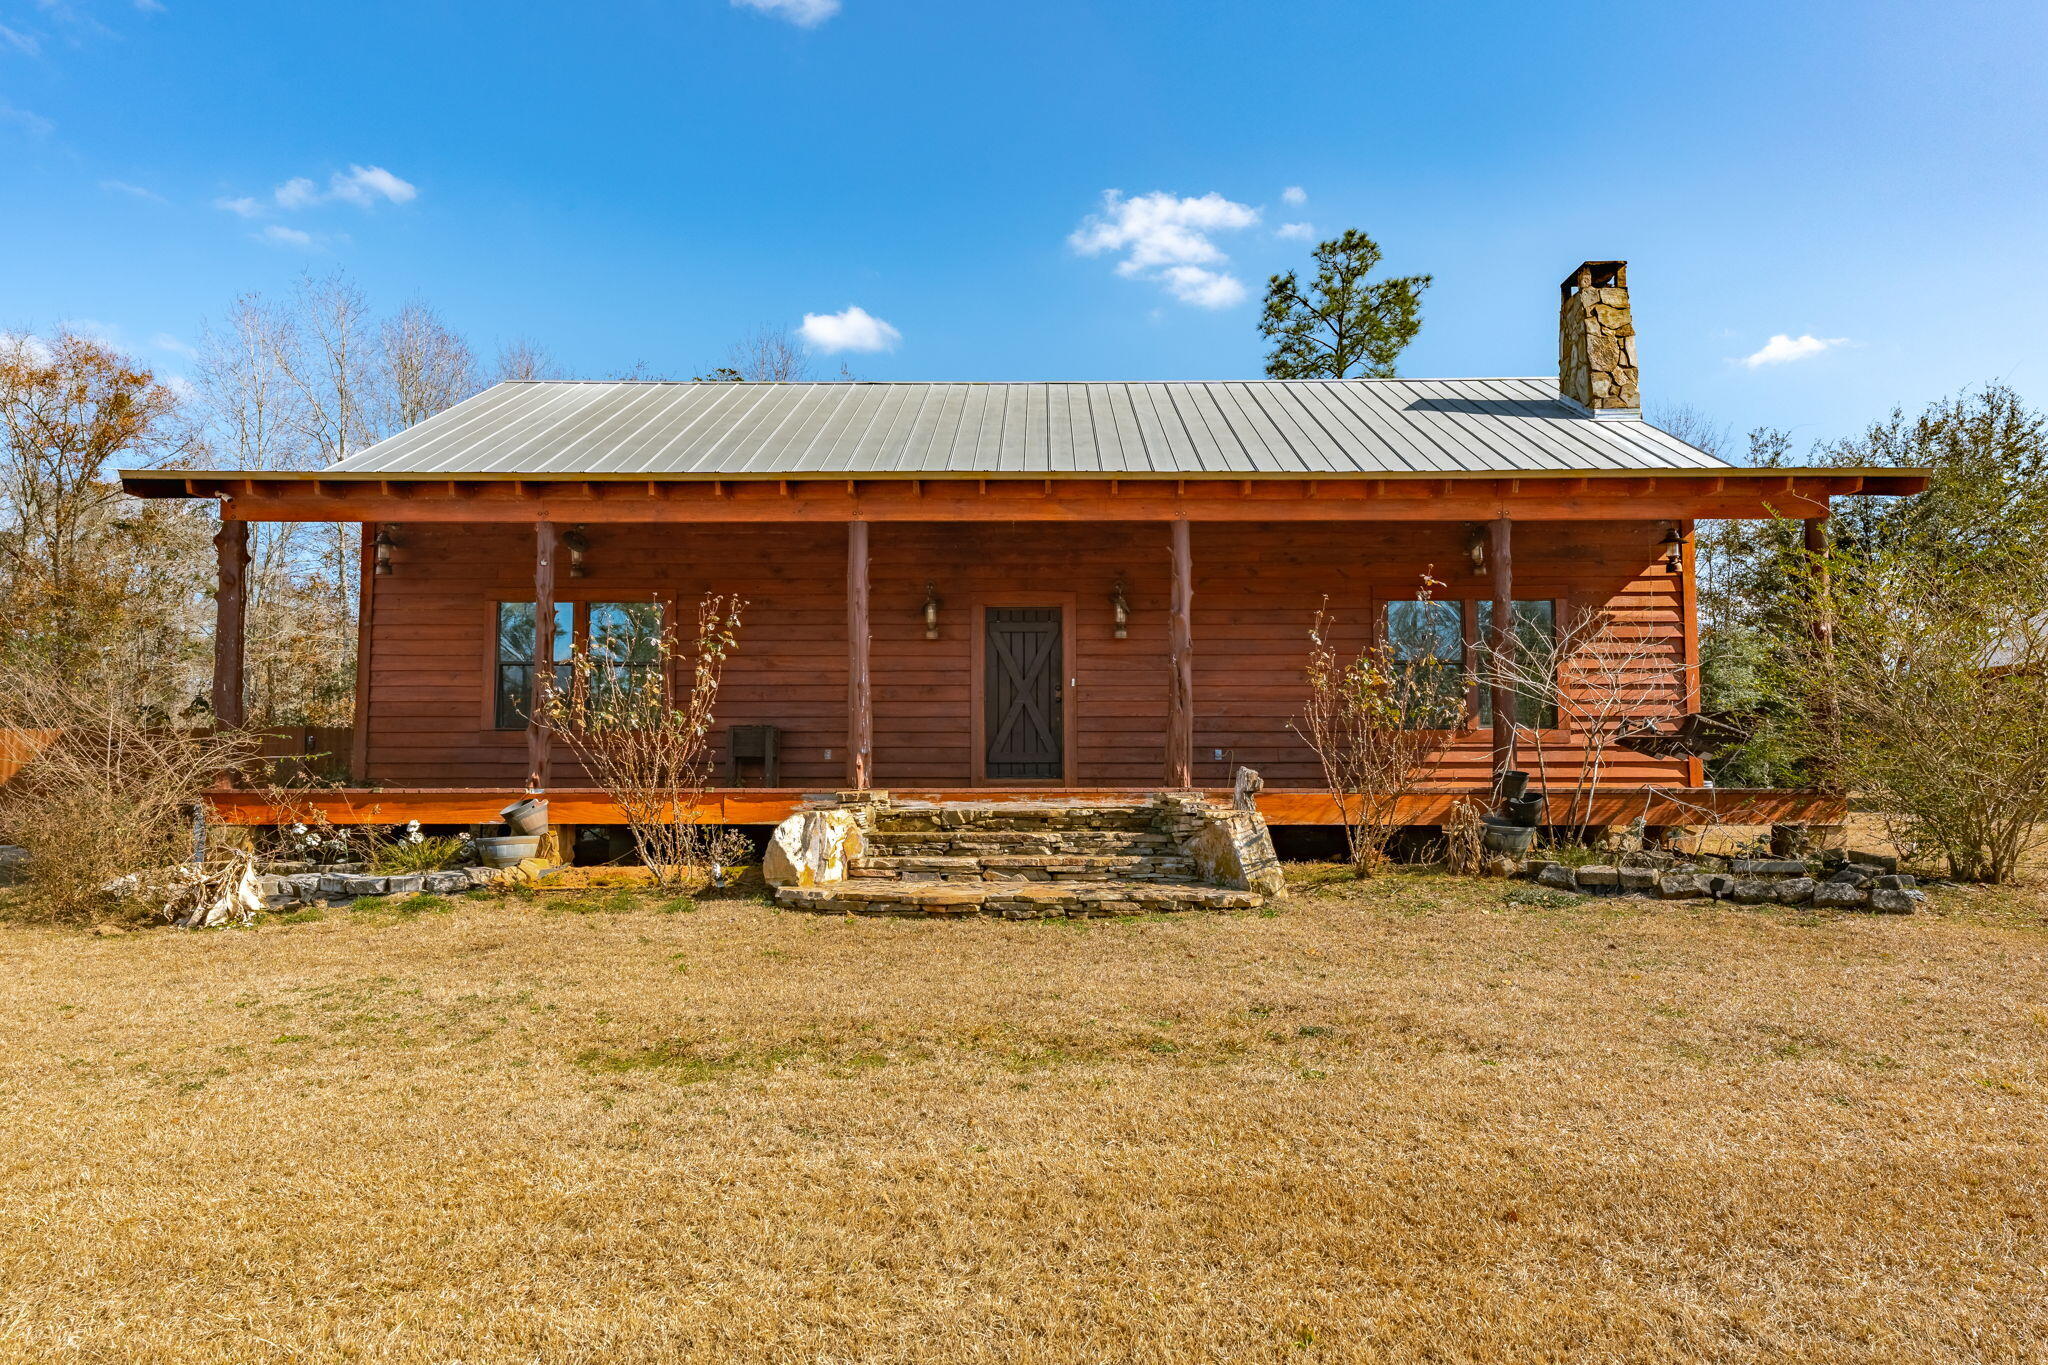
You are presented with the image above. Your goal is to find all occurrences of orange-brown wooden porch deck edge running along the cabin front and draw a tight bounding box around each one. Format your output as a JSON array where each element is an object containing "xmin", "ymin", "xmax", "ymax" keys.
[{"xmin": 207, "ymin": 786, "xmax": 1847, "ymax": 825}]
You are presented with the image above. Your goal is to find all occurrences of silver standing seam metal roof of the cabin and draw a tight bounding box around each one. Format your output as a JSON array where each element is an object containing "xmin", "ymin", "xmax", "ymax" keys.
[{"xmin": 322, "ymin": 379, "xmax": 1729, "ymax": 479}]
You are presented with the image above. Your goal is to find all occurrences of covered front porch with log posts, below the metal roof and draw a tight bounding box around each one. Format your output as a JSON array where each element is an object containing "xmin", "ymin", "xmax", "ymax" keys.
[{"xmin": 166, "ymin": 471, "xmax": 1878, "ymax": 825}]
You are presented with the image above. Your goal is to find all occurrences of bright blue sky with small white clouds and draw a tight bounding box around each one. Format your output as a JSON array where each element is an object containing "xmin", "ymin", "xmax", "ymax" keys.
[{"xmin": 0, "ymin": 0, "xmax": 2048, "ymax": 448}]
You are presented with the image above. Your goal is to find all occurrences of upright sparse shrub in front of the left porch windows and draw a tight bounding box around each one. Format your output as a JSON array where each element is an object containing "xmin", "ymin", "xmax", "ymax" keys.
[{"xmin": 541, "ymin": 593, "xmax": 743, "ymax": 888}]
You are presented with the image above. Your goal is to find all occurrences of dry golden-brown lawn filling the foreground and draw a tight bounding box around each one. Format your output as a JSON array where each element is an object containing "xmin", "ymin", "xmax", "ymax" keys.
[{"xmin": 0, "ymin": 876, "xmax": 2048, "ymax": 1365}]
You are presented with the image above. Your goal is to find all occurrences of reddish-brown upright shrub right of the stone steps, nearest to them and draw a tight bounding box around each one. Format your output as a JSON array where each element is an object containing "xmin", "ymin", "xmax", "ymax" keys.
[{"xmin": 1294, "ymin": 581, "xmax": 1468, "ymax": 876}]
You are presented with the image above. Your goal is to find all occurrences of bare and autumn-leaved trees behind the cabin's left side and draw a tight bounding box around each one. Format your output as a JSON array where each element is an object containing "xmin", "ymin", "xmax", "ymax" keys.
[{"xmin": 0, "ymin": 272, "xmax": 815, "ymax": 726}]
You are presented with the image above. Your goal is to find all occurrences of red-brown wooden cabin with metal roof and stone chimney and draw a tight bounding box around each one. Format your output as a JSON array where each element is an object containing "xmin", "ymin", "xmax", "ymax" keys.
[{"xmin": 123, "ymin": 260, "xmax": 1923, "ymax": 825}]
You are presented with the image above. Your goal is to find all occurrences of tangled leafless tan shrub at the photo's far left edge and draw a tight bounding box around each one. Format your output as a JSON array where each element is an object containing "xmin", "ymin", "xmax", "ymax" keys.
[{"xmin": 0, "ymin": 665, "xmax": 256, "ymax": 921}]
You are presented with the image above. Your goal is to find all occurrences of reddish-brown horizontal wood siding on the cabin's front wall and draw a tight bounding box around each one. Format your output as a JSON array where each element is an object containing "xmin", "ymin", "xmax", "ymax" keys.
[{"xmin": 367, "ymin": 522, "xmax": 1688, "ymax": 788}]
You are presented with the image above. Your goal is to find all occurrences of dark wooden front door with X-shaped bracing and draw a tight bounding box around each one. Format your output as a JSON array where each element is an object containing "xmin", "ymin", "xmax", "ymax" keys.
[{"xmin": 981, "ymin": 606, "xmax": 1067, "ymax": 782}]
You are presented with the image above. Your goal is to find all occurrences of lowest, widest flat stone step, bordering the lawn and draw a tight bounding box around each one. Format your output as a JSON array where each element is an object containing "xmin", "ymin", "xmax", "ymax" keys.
[{"xmin": 774, "ymin": 878, "xmax": 1266, "ymax": 919}]
